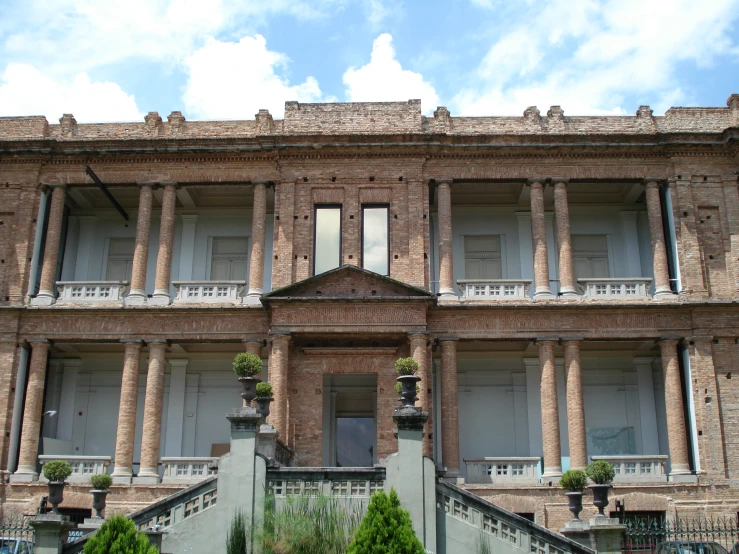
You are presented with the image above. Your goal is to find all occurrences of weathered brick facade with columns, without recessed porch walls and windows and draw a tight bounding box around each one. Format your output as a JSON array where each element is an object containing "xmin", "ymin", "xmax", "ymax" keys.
[{"xmin": 0, "ymin": 95, "xmax": 739, "ymax": 528}]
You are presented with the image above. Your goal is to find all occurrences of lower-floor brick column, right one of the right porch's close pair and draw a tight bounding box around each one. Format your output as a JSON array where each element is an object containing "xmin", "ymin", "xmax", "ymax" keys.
[{"xmin": 562, "ymin": 340, "xmax": 588, "ymax": 469}]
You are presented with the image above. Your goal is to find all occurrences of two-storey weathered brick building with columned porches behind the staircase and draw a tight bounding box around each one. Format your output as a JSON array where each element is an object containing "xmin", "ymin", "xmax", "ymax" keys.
[{"xmin": 0, "ymin": 95, "xmax": 739, "ymax": 528}]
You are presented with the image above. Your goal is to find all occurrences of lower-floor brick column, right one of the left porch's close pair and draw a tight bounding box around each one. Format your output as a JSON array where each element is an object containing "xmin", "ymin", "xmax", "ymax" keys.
[{"xmin": 134, "ymin": 340, "xmax": 167, "ymax": 484}]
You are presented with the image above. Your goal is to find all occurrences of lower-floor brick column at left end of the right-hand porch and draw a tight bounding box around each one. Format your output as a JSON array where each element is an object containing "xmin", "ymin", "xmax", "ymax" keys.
[{"xmin": 439, "ymin": 338, "xmax": 460, "ymax": 477}]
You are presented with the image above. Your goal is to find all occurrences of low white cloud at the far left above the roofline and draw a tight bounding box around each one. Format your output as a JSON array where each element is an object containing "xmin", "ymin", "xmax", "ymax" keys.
[{"xmin": 0, "ymin": 64, "xmax": 143, "ymax": 123}]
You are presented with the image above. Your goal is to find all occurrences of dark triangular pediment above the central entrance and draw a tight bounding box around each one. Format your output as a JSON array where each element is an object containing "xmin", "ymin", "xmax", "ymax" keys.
[{"xmin": 262, "ymin": 265, "xmax": 436, "ymax": 300}]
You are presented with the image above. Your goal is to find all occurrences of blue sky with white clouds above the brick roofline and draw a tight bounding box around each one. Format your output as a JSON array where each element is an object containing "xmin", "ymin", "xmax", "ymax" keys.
[{"xmin": 0, "ymin": 0, "xmax": 739, "ymax": 123}]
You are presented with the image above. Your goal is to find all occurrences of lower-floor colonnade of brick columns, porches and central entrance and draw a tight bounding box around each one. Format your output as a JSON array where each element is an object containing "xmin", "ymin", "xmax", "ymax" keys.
[{"xmin": 11, "ymin": 333, "xmax": 699, "ymax": 484}]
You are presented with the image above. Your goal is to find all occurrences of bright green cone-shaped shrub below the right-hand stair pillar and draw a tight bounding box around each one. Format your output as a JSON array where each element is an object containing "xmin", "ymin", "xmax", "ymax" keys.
[{"xmin": 346, "ymin": 489, "xmax": 424, "ymax": 554}]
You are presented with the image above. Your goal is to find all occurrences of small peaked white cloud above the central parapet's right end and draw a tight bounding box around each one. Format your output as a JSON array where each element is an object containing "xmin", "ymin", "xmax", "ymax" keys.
[{"xmin": 344, "ymin": 33, "xmax": 439, "ymax": 113}]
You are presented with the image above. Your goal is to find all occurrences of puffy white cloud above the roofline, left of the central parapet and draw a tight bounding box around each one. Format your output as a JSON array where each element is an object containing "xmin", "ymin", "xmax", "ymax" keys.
[{"xmin": 183, "ymin": 35, "xmax": 324, "ymax": 119}]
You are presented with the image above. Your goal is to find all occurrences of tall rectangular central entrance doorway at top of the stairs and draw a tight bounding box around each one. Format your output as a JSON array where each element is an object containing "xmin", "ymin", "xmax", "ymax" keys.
[{"xmin": 323, "ymin": 373, "xmax": 377, "ymax": 467}]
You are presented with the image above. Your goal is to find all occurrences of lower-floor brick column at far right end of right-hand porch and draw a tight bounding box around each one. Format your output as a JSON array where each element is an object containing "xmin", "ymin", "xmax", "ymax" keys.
[{"xmin": 659, "ymin": 339, "xmax": 690, "ymax": 478}]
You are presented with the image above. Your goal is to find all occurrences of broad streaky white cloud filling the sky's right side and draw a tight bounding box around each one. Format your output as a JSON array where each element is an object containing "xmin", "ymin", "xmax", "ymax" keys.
[{"xmin": 452, "ymin": 0, "xmax": 739, "ymax": 115}]
